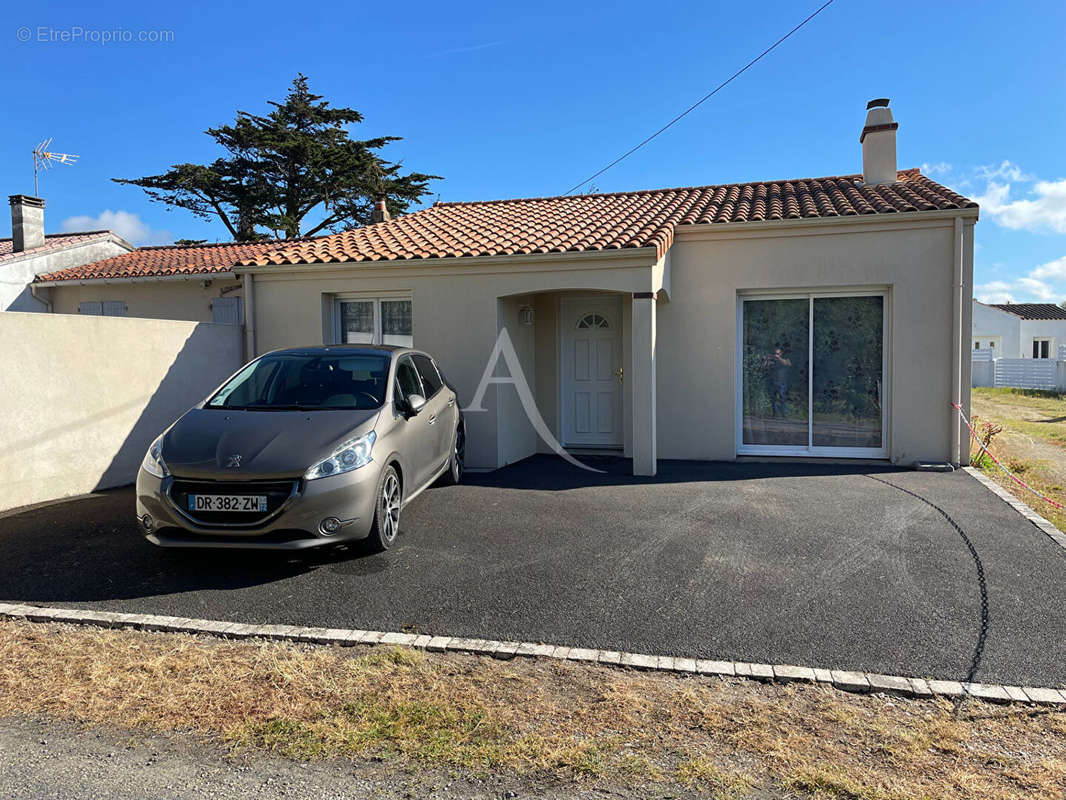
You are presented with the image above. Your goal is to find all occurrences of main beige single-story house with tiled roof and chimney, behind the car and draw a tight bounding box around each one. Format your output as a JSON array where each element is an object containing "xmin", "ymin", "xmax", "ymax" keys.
[{"xmin": 37, "ymin": 100, "xmax": 978, "ymax": 475}]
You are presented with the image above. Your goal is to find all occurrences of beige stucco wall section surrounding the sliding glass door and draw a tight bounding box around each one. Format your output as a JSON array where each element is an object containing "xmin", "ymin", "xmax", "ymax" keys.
[{"xmin": 658, "ymin": 214, "xmax": 975, "ymax": 464}]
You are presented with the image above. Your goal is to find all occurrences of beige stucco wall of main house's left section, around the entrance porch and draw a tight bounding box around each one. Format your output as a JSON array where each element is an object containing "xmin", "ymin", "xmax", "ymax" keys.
[{"xmin": 244, "ymin": 249, "xmax": 662, "ymax": 468}]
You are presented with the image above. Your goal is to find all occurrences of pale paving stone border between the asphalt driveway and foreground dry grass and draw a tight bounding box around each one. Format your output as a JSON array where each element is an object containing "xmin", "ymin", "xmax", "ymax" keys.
[{"xmin": 0, "ymin": 603, "xmax": 1066, "ymax": 706}]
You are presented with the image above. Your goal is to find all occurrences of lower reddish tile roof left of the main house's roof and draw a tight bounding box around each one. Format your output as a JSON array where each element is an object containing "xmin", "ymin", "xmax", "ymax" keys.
[{"xmin": 36, "ymin": 239, "xmax": 312, "ymax": 283}]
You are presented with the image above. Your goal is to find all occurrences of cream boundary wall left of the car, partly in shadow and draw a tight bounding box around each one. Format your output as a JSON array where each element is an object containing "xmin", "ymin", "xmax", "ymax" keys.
[{"xmin": 0, "ymin": 313, "xmax": 243, "ymax": 514}]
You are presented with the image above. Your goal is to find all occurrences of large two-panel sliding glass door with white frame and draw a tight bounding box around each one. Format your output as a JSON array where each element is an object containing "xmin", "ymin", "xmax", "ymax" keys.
[{"xmin": 737, "ymin": 293, "xmax": 887, "ymax": 458}]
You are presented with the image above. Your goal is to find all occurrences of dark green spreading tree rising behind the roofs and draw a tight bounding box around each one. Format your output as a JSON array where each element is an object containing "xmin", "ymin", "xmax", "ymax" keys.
[{"xmin": 113, "ymin": 75, "xmax": 439, "ymax": 241}]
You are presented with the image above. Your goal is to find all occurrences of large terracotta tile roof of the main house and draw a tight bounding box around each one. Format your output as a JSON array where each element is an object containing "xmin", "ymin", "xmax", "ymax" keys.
[{"xmin": 241, "ymin": 170, "xmax": 976, "ymax": 266}]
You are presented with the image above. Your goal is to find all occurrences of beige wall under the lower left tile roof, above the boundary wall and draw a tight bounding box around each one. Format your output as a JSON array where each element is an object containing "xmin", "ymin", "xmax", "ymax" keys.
[{"xmin": 36, "ymin": 274, "xmax": 241, "ymax": 322}]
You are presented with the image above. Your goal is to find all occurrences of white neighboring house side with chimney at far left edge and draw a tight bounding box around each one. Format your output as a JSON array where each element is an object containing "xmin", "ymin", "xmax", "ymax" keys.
[{"xmin": 0, "ymin": 194, "xmax": 134, "ymax": 311}]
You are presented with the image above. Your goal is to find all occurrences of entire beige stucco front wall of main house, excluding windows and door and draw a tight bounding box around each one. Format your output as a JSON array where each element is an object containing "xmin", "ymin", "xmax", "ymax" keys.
[{"xmin": 237, "ymin": 208, "xmax": 976, "ymax": 474}]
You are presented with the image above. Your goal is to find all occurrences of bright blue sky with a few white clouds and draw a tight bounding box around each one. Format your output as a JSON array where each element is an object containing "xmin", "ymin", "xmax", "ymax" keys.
[{"xmin": 0, "ymin": 0, "xmax": 1066, "ymax": 302}]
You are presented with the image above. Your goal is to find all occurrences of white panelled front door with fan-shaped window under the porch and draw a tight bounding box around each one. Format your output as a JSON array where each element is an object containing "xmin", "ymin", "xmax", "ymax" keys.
[{"xmin": 560, "ymin": 298, "xmax": 624, "ymax": 447}]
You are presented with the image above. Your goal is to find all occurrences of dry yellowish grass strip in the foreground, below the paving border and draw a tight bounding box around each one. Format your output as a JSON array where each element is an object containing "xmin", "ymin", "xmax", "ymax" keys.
[{"xmin": 0, "ymin": 622, "xmax": 1066, "ymax": 800}]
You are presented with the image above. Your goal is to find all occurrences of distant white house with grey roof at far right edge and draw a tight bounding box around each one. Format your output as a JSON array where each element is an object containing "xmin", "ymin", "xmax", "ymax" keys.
[{"xmin": 972, "ymin": 300, "xmax": 1066, "ymax": 358}]
